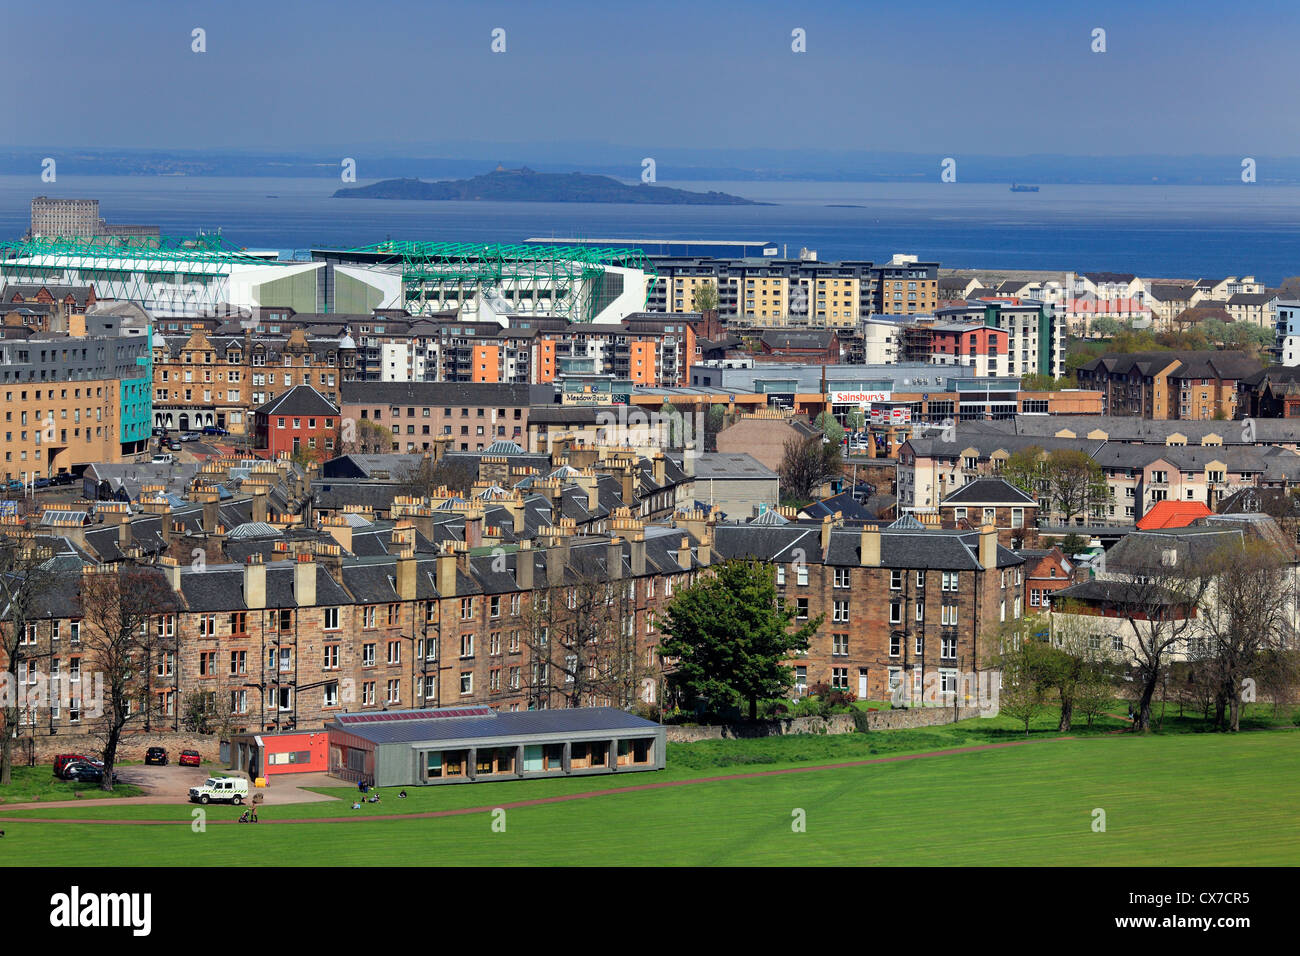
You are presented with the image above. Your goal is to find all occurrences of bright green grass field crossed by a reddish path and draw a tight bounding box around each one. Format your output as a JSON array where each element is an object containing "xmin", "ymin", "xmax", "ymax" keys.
[{"xmin": 0, "ymin": 713, "xmax": 1300, "ymax": 866}]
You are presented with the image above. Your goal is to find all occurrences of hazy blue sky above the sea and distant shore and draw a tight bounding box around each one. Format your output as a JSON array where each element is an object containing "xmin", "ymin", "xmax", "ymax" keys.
[{"xmin": 0, "ymin": 0, "xmax": 1300, "ymax": 163}]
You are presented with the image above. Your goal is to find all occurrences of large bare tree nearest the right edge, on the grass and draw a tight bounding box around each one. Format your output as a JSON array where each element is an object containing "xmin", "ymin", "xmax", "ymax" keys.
[{"xmin": 1192, "ymin": 540, "xmax": 1295, "ymax": 732}]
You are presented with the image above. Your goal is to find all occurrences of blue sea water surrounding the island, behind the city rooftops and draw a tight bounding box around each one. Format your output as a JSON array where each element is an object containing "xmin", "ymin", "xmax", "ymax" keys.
[{"xmin": 0, "ymin": 176, "xmax": 1300, "ymax": 284}]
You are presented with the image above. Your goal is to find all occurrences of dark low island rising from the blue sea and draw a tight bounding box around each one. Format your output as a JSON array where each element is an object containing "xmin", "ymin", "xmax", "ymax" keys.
[{"xmin": 334, "ymin": 166, "xmax": 770, "ymax": 206}]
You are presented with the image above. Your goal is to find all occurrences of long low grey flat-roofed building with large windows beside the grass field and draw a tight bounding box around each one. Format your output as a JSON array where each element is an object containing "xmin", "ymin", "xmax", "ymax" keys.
[{"xmin": 326, "ymin": 705, "xmax": 664, "ymax": 787}]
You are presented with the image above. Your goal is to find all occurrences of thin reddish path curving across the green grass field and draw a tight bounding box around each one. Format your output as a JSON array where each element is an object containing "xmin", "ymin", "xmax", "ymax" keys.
[{"xmin": 0, "ymin": 736, "xmax": 1080, "ymax": 826}]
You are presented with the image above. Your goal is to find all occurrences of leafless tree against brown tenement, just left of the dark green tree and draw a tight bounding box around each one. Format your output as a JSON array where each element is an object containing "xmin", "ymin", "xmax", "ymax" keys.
[{"xmin": 516, "ymin": 567, "xmax": 651, "ymax": 708}]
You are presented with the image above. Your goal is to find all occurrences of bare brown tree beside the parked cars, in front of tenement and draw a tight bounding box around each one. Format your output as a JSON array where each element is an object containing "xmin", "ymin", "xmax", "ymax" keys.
[{"xmin": 77, "ymin": 566, "xmax": 179, "ymax": 791}]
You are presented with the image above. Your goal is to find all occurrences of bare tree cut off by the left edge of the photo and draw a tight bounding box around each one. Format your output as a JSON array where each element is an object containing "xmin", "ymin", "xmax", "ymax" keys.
[{"xmin": 0, "ymin": 535, "xmax": 57, "ymax": 786}]
